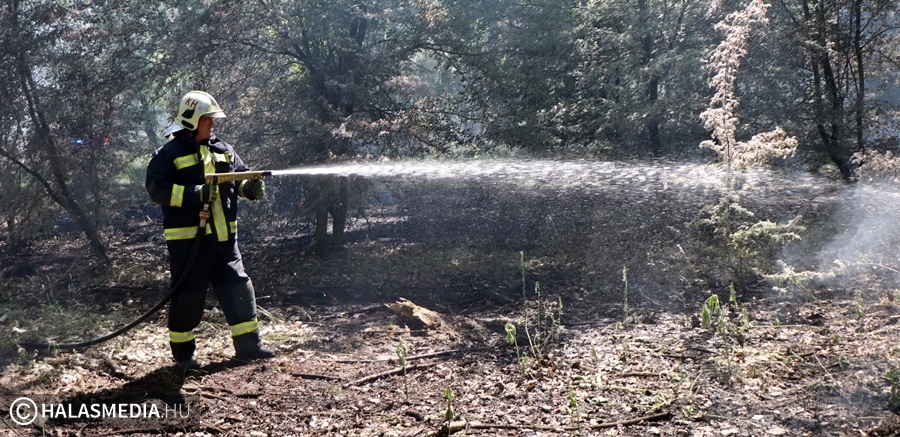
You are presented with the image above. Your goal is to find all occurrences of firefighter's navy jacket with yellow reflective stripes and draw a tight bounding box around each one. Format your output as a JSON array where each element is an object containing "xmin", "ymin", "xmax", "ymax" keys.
[{"xmin": 145, "ymin": 136, "xmax": 249, "ymax": 244}]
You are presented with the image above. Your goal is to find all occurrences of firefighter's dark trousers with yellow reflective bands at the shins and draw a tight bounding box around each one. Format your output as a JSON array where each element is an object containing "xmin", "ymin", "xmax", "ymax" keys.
[{"xmin": 167, "ymin": 240, "xmax": 261, "ymax": 361}]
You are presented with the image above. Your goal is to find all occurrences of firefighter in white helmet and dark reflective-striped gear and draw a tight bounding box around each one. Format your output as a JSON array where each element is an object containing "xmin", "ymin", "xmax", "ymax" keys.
[{"xmin": 145, "ymin": 91, "xmax": 275, "ymax": 371}]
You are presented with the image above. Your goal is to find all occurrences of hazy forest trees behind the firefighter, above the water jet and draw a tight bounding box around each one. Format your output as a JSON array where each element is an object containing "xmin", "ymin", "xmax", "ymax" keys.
[{"xmin": 0, "ymin": 0, "xmax": 900, "ymax": 255}]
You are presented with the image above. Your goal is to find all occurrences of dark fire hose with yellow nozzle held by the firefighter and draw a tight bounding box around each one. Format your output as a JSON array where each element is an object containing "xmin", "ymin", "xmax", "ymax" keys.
[{"xmin": 18, "ymin": 170, "xmax": 272, "ymax": 350}]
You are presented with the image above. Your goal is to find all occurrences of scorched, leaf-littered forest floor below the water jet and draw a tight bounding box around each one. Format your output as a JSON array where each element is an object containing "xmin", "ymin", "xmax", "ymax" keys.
[{"xmin": 0, "ymin": 163, "xmax": 900, "ymax": 436}]
